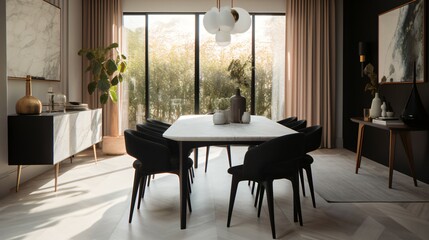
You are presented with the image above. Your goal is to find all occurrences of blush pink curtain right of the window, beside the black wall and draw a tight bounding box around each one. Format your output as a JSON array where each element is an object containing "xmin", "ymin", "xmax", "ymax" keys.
[{"xmin": 285, "ymin": 0, "xmax": 336, "ymax": 148}]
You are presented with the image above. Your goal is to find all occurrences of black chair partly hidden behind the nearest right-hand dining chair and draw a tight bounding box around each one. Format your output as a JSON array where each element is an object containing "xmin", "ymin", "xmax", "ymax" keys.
[{"xmin": 298, "ymin": 125, "xmax": 322, "ymax": 207}]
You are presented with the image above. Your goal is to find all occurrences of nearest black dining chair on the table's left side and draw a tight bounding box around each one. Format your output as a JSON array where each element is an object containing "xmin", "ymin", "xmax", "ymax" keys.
[{"xmin": 124, "ymin": 129, "xmax": 193, "ymax": 223}]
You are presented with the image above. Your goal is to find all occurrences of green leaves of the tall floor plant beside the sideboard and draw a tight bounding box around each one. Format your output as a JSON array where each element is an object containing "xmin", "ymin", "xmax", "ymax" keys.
[{"xmin": 78, "ymin": 43, "xmax": 127, "ymax": 104}]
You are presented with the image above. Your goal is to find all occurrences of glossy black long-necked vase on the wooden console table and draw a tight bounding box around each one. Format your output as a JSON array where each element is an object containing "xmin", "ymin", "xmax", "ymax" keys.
[{"xmin": 401, "ymin": 63, "xmax": 428, "ymax": 127}]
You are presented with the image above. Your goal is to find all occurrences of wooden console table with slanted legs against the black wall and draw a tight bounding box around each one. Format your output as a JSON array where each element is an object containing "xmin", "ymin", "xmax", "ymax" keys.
[{"xmin": 351, "ymin": 117, "xmax": 427, "ymax": 188}]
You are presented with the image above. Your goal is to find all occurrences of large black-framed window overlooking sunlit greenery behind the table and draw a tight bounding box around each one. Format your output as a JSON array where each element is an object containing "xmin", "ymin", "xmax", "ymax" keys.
[{"xmin": 121, "ymin": 13, "xmax": 285, "ymax": 129}]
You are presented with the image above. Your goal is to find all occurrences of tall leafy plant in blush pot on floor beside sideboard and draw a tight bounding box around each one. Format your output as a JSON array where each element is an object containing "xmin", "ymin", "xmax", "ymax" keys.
[{"xmin": 78, "ymin": 43, "xmax": 127, "ymax": 154}]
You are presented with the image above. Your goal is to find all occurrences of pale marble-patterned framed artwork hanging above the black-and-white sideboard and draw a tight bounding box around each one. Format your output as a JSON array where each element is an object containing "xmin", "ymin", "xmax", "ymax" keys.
[{"xmin": 6, "ymin": 0, "xmax": 61, "ymax": 80}]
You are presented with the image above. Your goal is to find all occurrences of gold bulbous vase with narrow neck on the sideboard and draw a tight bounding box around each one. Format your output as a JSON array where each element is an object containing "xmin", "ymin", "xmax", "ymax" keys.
[{"xmin": 15, "ymin": 75, "xmax": 42, "ymax": 115}]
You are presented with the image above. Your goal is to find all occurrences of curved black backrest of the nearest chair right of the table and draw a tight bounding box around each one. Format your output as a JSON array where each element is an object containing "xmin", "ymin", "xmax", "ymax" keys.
[{"xmin": 243, "ymin": 133, "xmax": 305, "ymax": 180}]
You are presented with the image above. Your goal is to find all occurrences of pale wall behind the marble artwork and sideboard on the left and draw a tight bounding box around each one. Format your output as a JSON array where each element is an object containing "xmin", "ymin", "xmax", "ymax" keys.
[{"xmin": 0, "ymin": 0, "xmax": 82, "ymax": 196}]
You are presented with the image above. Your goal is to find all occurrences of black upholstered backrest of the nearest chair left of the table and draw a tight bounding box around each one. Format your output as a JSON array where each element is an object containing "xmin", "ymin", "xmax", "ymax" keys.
[{"xmin": 124, "ymin": 129, "xmax": 173, "ymax": 174}]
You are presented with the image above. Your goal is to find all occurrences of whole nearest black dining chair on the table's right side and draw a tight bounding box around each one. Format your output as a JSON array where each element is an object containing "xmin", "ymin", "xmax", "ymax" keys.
[{"xmin": 227, "ymin": 133, "xmax": 305, "ymax": 238}]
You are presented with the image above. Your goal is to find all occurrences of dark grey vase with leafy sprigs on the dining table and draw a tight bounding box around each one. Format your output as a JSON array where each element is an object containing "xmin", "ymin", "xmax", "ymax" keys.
[{"xmin": 228, "ymin": 59, "xmax": 251, "ymax": 123}]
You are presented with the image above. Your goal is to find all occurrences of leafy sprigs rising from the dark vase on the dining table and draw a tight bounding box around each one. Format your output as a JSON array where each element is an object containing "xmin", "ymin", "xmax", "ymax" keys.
[{"xmin": 228, "ymin": 58, "xmax": 252, "ymax": 88}]
